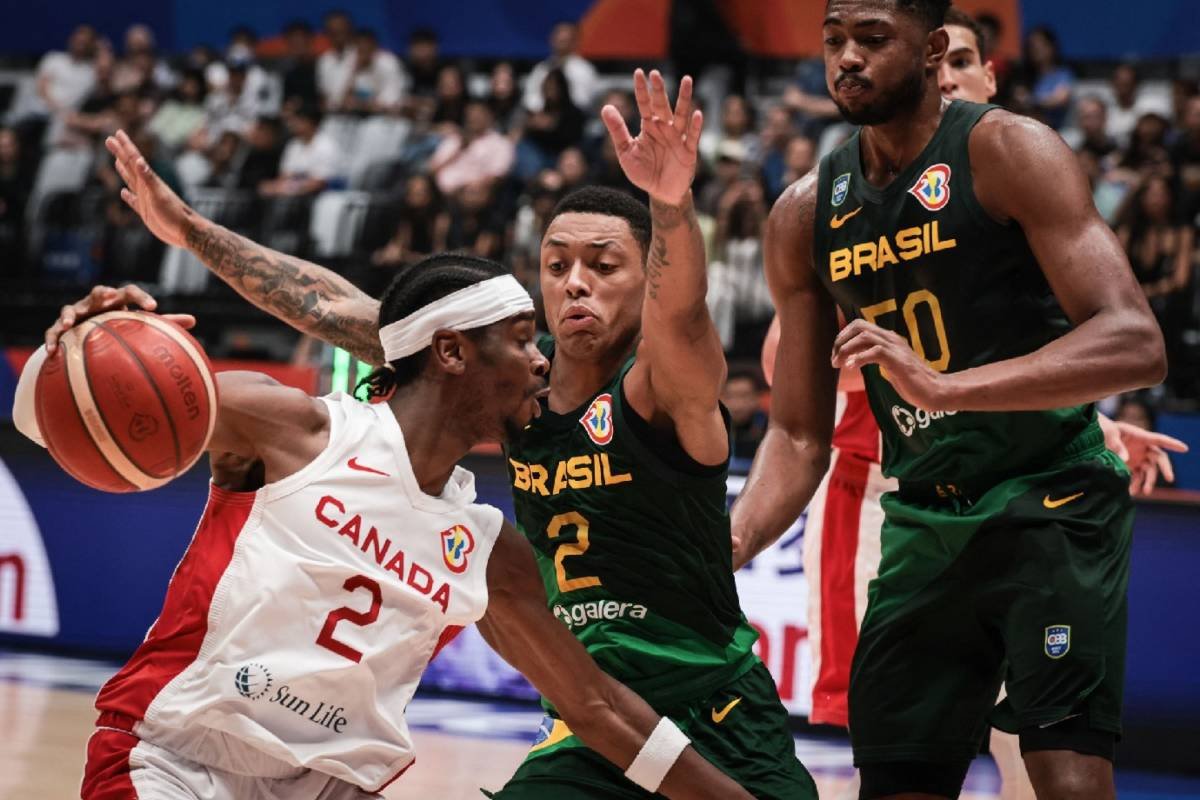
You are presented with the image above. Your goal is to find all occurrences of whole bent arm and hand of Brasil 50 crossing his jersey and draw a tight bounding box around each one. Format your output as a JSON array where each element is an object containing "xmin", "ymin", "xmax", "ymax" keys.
[{"xmin": 833, "ymin": 112, "xmax": 1166, "ymax": 411}]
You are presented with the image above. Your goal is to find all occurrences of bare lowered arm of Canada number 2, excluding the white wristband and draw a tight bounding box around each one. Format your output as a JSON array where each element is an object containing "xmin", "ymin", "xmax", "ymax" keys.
[{"xmin": 479, "ymin": 522, "xmax": 751, "ymax": 800}]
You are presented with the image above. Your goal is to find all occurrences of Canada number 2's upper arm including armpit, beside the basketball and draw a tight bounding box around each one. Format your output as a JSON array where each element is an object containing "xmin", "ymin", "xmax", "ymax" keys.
[{"xmin": 209, "ymin": 372, "xmax": 329, "ymax": 482}]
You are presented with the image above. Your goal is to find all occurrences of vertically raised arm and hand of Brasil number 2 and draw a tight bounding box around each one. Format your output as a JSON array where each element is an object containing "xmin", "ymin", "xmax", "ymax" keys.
[{"xmin": 601, "ymin": 70, "xmax": 728, "ymax": 464}]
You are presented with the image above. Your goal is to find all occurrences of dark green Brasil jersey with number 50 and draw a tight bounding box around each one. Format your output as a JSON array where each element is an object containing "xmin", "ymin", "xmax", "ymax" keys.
[{"xmin": 814, "ymin": 101, "xmax": 1102, "ymax": 487}]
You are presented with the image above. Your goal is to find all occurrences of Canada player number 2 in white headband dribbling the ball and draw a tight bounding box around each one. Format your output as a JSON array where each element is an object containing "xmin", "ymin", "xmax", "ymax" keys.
[{"xmin": 14, "ymin": 260, "xmax": 750, "ymax": 800}]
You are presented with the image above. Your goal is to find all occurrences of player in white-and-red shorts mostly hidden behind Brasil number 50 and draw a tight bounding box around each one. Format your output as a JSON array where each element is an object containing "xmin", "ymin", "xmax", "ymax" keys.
[{"xmin": 762, "ymin": 8, "xmax": 1187, "ymax": 800}]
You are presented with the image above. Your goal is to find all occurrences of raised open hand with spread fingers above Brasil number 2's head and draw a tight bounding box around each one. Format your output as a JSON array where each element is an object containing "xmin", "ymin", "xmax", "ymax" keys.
[{"xmin": 600, "ymin": 70, "xmax": 704, "ymax": 205}]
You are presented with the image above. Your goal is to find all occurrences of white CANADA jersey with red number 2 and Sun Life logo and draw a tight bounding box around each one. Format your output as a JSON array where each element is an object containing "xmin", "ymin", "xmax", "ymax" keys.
[{"xmin": 96, "ymin": 393, "xmax": 503, "ymax": 792}]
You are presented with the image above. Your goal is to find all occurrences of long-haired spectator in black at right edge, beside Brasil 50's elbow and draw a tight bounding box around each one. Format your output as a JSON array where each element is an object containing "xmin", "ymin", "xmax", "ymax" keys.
[{"xmin": 1117, "ymin": 175, "xmax": 1195, "ymax": 345}]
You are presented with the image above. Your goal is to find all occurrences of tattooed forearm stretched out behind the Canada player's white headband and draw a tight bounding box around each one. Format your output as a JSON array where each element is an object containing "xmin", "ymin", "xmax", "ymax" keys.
[{"xmin": 187, "ymin": 223, "xmax": 383, "ymax": 363}]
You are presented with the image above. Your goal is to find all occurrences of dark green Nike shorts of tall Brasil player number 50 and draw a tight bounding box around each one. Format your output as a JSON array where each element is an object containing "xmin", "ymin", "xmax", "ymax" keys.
[{"xmin": 850, "ymin": 449, "xmax": 1133, "ymax": 765}]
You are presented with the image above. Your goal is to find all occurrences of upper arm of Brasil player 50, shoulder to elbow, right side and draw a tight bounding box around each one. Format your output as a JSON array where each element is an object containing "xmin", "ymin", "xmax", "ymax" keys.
[{"xmin": 970, "ymin": 112, "xmax": 1145, "ymax": 325}]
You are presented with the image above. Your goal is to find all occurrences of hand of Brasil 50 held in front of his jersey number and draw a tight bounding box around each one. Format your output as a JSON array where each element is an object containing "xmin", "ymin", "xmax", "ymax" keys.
[{"xmin": 830, "ymin": 319, "xmax": 958, "ymax": 411}]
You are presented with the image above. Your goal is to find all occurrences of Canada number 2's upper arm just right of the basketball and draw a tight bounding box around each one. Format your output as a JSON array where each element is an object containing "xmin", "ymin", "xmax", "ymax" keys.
[{"xmin": 209, "ymin": 371, "xmax": 329, "ymax": 458}]
